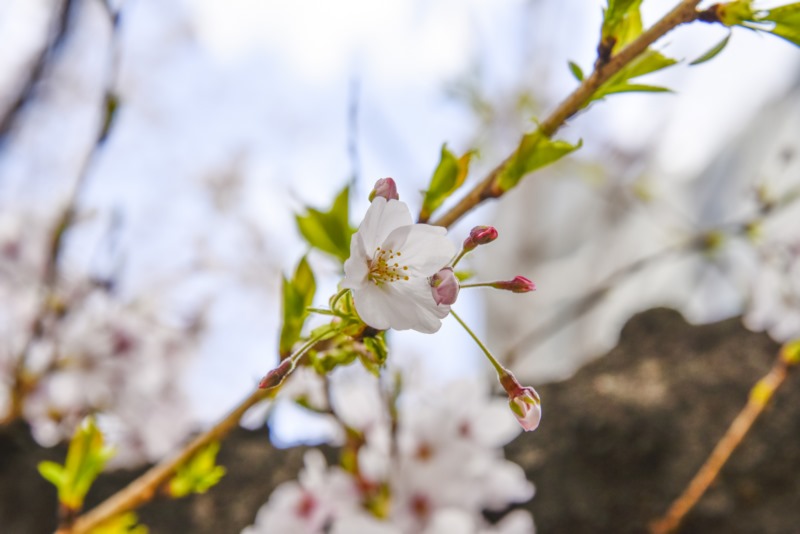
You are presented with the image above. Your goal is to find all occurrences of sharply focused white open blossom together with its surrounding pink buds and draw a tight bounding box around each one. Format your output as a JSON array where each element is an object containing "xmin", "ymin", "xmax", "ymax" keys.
[{"xmin": 332, "ymin": 178, "xmax": 542, "ymax": 436}]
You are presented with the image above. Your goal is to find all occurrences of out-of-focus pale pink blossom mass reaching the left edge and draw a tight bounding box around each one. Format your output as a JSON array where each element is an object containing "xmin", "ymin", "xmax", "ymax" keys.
[{"xmin": 0, "ymin": 212, "xmax": 199, "ymax": 465}]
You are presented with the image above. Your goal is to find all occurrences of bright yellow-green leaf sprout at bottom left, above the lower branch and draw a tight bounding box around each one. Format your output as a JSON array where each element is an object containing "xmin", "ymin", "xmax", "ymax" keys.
[{"xmin": 38, "ymin": 417, "xmax": 114, "ymax": 511}]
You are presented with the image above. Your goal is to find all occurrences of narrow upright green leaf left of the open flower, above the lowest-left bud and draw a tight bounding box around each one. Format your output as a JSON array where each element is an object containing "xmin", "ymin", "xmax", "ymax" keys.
[{"xmin": 278, "ymin": 256, "xmax": 317, "ymax": 358}]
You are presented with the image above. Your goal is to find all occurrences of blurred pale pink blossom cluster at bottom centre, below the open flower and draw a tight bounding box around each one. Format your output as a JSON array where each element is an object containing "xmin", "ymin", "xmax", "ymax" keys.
[{"xmin": 245, "ymin": 368, "xmax": 533, "ymax": 534}]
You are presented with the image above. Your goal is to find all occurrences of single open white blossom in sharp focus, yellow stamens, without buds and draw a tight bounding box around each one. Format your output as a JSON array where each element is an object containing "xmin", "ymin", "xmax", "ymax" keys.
[{"xmin": 342, "ymin": 197, "xmax": 455, "ymax": 334}]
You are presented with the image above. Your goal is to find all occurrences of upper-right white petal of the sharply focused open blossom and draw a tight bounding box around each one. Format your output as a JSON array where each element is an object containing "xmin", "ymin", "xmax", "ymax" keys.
[{"xmin": 382, "ymin": 224, "xmax": 455, "ymax": 277}]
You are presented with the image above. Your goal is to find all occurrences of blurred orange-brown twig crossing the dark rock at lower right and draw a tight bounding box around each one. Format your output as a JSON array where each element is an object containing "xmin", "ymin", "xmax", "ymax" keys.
[{"xmin": 650, "ymin": 342, "xmax": 800, "ymax": 534}]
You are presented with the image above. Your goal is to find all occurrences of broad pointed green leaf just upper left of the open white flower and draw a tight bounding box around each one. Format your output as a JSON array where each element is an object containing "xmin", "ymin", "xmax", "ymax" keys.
[{"xmin": 295, "ymin": 187, "xmax": 355, "ymax": 262}]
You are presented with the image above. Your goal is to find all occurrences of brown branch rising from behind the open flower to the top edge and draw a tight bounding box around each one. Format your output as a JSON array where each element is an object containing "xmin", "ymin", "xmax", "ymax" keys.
[{"xmin": 431, "ymin": 0, "xmax": 700, "ymax": 226}]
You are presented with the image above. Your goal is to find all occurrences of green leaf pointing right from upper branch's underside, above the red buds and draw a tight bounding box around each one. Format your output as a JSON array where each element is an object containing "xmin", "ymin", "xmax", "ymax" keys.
[{"xmin": 497, "ymin": 130, "xmax": 583, "ymax": 192}]
